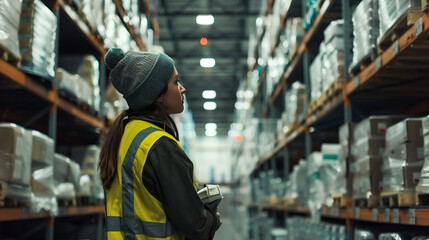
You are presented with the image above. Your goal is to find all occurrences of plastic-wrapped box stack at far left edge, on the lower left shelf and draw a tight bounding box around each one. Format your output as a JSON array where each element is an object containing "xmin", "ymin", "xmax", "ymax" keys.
[{"xmin": 0, "ymin": 123, "xmax": 32, "ymax": 186}]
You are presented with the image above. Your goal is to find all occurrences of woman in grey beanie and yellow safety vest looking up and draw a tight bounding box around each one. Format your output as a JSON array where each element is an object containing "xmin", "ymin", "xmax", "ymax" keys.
[{"xmin": 99, "ymin": 48, "xmax": 221, "ymax": 240}]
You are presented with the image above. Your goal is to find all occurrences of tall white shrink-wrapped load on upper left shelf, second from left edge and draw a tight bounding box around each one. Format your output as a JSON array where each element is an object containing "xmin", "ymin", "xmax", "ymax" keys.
[{"xmin": 19, "ymin": 0, "xmax": 57, "ymax": 78}]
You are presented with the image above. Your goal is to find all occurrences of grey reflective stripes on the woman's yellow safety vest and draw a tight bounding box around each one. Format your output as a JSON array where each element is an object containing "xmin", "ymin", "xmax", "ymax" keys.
[{"xmin": 106, "ymin": 127, "xmax": 173, "ymax": 239}]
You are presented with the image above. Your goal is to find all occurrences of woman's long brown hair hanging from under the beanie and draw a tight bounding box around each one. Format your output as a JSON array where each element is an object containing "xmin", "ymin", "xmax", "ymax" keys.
[{"xmin": 98, "ymin": 84, "xmax": 179, "ymax": 189}]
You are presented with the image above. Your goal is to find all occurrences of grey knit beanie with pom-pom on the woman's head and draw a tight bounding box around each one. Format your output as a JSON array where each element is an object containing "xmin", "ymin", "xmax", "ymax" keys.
[{"xmin": 104, "ymin": 48, "xmax": 174, "ymax": 111}]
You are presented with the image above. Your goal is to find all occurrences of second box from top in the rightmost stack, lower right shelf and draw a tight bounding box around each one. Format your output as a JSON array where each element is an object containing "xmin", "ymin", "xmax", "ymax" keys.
[{"xmin": 384, "ymin": 142, "xmax": 424, "ymax": 163}]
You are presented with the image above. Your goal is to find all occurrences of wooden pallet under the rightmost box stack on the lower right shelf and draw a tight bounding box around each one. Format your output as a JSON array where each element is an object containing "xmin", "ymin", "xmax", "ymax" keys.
[{"xmin": 381, "ymin": 190, "xmax": 418, "ymax": 207}]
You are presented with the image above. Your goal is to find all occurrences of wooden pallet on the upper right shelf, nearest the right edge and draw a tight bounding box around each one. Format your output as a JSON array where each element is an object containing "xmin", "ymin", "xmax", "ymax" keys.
[{"xmin": 378, "ymin": 8, "xmax": 424, "ymax": 54}]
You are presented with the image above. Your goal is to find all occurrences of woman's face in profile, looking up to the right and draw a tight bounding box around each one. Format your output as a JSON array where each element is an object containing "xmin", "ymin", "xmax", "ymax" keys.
[{"xmin": 156, "ymin": 67, "xmax": 186, "ymax": 114}]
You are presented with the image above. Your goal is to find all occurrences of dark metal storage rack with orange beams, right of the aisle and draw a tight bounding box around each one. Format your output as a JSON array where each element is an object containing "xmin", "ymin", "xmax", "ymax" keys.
[{"xmin": 236, "ymin": 0, "xmax": 429, "ymax": 239}]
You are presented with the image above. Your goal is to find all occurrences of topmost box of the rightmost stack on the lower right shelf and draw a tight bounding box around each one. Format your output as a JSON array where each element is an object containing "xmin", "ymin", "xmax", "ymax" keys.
[{"xmin": 386, "ymin": 118, "xmax": 423, "ymax": 147}]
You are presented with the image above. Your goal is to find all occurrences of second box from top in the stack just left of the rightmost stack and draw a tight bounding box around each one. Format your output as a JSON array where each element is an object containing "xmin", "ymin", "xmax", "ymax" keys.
[{"xmin": 350, "ymin": 137, "xmax": 385, "ymax": 160}]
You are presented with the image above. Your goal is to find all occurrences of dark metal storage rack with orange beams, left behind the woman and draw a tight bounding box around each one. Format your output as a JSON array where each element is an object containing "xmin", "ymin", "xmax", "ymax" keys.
[{"xmin": 0, "ymin": 0, "xmax": 154, "ymax": 239}]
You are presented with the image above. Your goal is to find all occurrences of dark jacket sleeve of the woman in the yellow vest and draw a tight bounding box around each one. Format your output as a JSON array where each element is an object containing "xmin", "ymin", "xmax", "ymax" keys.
[{"xmin": 143, "ymin": 137, "xmax": 219, "ymax": 240}]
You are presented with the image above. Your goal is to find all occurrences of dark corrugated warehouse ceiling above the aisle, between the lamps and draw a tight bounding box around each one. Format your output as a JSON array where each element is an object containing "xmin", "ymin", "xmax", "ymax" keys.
[{"xmin": 154, "ymin": 0, "xmax": 261, "ymax": 136}]
